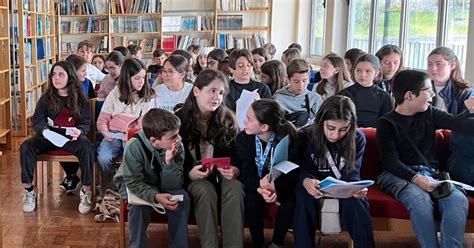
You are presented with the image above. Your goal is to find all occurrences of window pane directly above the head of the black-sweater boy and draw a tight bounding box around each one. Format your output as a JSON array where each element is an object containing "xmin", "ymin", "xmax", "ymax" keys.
[{"xmin": 405, "ymin": 0, "xmax": 438, "ymax": 70}]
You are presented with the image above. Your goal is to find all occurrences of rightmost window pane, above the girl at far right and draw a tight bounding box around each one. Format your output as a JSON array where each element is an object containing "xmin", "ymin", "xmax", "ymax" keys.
[{"xmin": 446, "ymin": 0, "xmax": 471, "ymax": 72}]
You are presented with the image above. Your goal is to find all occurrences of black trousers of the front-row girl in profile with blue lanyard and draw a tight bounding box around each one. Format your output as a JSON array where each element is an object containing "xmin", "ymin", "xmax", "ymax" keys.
[{"xmin": 245, "ymin": 190, "xmax": 294, "ymax": 248}]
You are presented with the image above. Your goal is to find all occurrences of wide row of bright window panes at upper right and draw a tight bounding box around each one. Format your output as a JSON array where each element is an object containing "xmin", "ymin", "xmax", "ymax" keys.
[{"xmin": 347, "ymin": 0, "xmax": 470, "ymax": 70}]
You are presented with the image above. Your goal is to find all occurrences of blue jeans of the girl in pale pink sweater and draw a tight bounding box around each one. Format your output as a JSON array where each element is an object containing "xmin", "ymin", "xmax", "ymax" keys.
[{"xmin": 97, "ymin": 139, "xmax": 125, "ymax": 189}]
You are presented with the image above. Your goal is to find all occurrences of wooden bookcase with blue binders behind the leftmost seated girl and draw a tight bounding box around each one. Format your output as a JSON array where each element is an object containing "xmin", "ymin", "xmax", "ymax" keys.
[{"xmin": 9, "ymin": 0, "xmax": 57, "ymax": 136}]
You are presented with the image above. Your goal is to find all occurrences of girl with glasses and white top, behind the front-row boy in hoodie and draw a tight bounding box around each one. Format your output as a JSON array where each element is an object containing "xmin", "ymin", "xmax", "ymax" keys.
[{"xmin": 155, "ymin": 55, "xmax": 193, "ymax": 112}]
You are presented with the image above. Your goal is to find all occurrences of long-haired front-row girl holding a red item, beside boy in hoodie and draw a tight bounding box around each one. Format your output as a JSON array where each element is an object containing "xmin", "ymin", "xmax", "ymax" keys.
[{"xmin": 176, "ymin": 69, "xmax": 244, "ymax": 248}]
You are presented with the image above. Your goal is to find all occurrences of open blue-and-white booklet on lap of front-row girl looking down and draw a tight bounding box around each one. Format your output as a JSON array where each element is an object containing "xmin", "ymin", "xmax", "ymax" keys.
[{"xmin": 319, "ymin": 177, "xmax": 374, "ymax": 198}]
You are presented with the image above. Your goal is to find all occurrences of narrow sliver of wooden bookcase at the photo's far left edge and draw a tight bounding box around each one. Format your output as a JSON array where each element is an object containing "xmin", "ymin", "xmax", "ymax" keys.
[{"xmin": 0, "ymin": 0, "xmax": 12, "ymax": 150}]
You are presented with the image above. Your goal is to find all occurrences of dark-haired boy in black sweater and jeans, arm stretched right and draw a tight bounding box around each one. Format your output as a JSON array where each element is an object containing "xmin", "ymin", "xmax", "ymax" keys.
[{"xmin": 376, "ymin": 70, "xmax": 474, "ymax": 247}]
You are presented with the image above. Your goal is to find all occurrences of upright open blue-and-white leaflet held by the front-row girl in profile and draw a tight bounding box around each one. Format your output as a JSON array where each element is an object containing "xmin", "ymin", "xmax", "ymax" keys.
[{"xmin": 269, "ymin": 135, "xmax": 299, "ymax": 180}]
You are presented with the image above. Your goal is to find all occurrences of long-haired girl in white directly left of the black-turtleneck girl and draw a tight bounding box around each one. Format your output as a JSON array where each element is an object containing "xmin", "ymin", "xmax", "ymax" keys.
[{"xmin": 313, "ymin": 53, "xmax": 352, "ymax": 100}]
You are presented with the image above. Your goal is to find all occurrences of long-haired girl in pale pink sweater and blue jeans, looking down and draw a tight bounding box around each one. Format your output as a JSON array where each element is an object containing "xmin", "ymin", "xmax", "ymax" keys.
[{"xmin": 97, "ymin": 58, "xmax": 155, "ymax": 193}]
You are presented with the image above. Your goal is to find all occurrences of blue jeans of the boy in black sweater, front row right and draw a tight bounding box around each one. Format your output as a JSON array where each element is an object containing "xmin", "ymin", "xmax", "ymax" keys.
[{"xmin": 378, "ymin": 166, "xmax": 468, "ymax": 248}]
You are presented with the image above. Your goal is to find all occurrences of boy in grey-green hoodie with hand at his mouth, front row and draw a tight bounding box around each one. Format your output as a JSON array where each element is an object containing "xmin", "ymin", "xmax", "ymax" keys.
[{"xmin": 114, "ymin": 109, "xmax": 191, "ymax": 247}]
